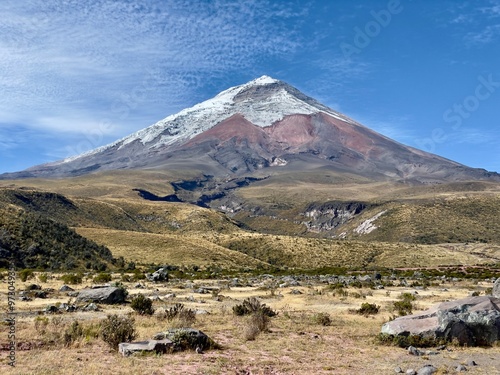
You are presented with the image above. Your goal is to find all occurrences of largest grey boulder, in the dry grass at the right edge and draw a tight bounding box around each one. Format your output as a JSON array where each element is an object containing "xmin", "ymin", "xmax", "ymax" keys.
[{"xmin": 382, "ymin": 296, "xmax": 500, "ymax": 346}]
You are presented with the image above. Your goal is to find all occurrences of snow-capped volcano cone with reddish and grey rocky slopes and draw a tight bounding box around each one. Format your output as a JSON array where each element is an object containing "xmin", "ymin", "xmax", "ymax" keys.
[{"xmin": 1, "ymin": 76, "xmax": 500, "ymax": 182}]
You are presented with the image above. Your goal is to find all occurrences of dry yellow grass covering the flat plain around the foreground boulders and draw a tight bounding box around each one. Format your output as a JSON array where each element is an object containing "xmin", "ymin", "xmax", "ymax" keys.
[{"xmin": 0, "ymin": 275, "xmax": 500, "ymax": 375}]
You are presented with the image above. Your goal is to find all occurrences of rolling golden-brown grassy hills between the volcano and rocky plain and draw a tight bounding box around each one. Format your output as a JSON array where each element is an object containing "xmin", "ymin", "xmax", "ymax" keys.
[{"xmin": 0, "ymin": 178, "xmax": 500, "ymax": 269}]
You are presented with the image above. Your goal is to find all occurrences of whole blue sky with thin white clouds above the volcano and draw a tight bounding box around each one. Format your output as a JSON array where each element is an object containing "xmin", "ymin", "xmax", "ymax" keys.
[{"xmin": 0, "ymin": 0, "xmax": 500, "ymax": 173}]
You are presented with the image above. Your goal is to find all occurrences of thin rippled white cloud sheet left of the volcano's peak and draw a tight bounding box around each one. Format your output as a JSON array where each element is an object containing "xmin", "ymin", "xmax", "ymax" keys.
[{"xmin": 0, "ymin": 0, "xmax": 307, "ymax": 140}]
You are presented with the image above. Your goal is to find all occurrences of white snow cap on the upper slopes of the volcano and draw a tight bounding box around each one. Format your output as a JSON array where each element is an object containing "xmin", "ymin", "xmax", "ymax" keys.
[{"xmin": 60, "ymin": 75, "xmax": 356, "ymax": 164}]
